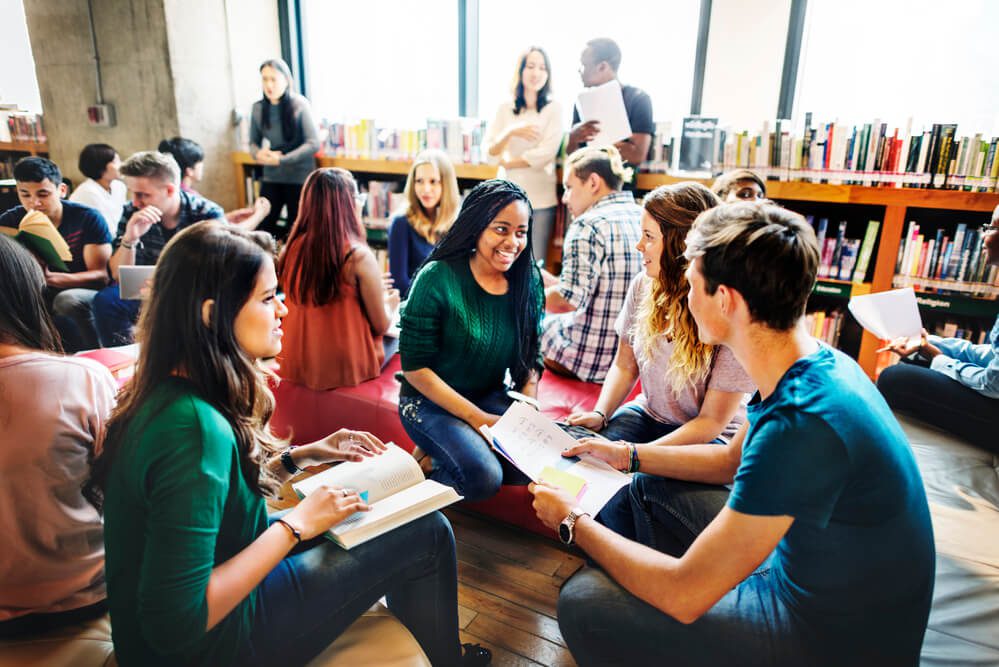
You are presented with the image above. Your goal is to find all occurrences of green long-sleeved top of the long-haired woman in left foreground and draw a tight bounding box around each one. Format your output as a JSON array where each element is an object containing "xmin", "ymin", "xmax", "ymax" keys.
[{"xmin": 104, "ymin": 378, "xmax": 267, "ymax": 667}]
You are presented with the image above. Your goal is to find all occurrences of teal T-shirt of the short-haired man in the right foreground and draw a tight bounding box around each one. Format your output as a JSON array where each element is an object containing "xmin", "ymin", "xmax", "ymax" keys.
[{"xmin": 728, "ymin": 346, "xmax": 935, "ymax": 665}]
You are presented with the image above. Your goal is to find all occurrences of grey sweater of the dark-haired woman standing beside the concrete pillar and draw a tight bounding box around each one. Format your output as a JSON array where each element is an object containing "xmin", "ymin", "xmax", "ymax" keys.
[{"xmin": 250, "ymin": 93, "xmax": 319, "ymax": 184}]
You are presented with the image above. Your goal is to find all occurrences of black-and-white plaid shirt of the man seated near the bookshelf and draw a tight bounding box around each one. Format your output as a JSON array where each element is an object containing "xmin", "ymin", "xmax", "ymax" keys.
[{"xmin": 541, "ymin": 192, "xmax": 642, "ymax": 382}]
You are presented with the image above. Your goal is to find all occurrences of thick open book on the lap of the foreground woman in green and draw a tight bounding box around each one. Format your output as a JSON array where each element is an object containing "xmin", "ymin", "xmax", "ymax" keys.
[{"xmin": 291, "ymin": 442, "xmax": 461, "ymax": 549}]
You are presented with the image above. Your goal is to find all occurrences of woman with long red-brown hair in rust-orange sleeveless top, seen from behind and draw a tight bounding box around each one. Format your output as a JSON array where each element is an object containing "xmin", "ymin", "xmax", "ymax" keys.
[{"xmin": 278, "ymin": 168, "xmax": 399, "ymax": 390}]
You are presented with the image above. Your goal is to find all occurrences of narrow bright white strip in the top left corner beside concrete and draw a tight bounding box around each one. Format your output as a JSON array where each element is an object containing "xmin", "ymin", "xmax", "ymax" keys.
[{"xmin": 0, "ymin": 0, "xmax": 42, "ymax": 113}]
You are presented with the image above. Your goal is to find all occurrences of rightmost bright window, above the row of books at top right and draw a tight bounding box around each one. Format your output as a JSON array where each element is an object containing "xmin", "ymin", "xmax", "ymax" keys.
[{"xmin": 794, "ymin": 0, "xmax": 999, "ymax": 136}]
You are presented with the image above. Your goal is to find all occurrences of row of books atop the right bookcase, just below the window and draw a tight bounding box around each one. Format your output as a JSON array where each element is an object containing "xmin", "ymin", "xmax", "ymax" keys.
[{"xmin": 720, "ymin": 113, "xmax": 999, "ymax": 192}]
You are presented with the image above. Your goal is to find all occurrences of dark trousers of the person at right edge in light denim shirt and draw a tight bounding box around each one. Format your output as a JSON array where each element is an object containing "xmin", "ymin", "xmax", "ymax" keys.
[{"xmin": 878, "ymin": 363, "xmax": 999, "ymax": 454}]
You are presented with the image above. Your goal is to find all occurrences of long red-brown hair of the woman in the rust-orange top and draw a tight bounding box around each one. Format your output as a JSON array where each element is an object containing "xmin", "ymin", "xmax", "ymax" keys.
[{"xmin": 278, "ymin": 167, "xmax": 364, "ymax": 306}]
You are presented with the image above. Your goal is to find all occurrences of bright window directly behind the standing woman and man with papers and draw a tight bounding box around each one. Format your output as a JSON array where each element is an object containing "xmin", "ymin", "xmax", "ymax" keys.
[{"xmin": 479, "ymin": 0, "xmax": 701, "ymax": 127}]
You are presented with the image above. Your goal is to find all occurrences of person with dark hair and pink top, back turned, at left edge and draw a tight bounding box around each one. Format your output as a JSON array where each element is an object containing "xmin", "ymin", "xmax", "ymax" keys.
[{"xmin": 0, "ymin": 234, "xmax": 117, "ymax": 638}]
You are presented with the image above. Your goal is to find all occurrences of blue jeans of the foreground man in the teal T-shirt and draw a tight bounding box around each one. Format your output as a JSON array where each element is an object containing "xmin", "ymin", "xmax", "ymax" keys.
[{"xmin": 558, "ymin": 473, "xmax": 817, "ymax": 667}]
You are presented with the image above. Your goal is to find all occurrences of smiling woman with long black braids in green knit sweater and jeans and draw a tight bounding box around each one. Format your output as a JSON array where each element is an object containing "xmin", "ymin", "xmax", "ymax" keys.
[{"xmin": 399, "ymin": 180, "xmax": 542, "ymax": 501}]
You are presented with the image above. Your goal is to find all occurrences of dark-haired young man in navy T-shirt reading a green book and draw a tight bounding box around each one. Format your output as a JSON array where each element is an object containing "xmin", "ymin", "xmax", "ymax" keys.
[{"xmin": 0, "ymin": 157, "xmax": 111, "ymax": 352}]
